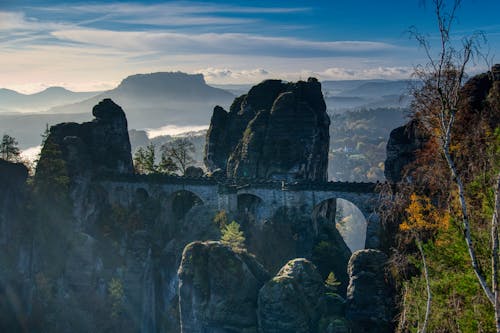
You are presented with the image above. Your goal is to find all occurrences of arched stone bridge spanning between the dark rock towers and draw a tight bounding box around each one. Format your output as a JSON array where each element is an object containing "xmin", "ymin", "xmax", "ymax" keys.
[{"xmin": 97, "ymin": 175, "xmax": 380, "ymax": 248}]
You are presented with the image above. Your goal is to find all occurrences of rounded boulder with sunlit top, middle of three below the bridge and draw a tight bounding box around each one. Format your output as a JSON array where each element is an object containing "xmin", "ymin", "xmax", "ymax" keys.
[{"xmin": 258, "ymin": 258, "xmax": 327, "ymax": 333}]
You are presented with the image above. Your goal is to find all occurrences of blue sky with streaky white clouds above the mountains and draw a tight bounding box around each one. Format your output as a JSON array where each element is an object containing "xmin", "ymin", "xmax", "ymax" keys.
[{"xmin": 0, "ymin": 0, "xmax": 500, "ymax": 93}]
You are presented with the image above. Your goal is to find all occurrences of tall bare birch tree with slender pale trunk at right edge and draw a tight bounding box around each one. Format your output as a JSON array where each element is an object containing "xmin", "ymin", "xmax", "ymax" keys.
[{"xmin": 412, "ymin": 0, "xmax": 500, "ymax": 333}]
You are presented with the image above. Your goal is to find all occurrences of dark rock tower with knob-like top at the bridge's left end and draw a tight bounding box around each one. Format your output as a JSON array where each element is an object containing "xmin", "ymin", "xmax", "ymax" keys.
[{"xmin": 37, "ymin": 99, "xmax": 134, "ymax": 176}]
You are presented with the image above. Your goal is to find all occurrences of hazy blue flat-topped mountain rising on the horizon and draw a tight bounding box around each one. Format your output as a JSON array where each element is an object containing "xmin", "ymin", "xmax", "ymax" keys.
[{"xmin": 49, "ymin": 72, "xmax": 234, "ymax": 128}]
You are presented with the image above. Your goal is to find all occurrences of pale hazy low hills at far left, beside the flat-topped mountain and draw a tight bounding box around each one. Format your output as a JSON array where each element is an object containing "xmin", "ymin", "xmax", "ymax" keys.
[{"xmin": 0, "ymin": 87, "xmax": 100, "ymax": 113}]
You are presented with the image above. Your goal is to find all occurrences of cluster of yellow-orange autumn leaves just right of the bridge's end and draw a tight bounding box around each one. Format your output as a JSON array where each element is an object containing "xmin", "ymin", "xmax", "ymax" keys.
[{"xmin": 399, "ymin": 193, "xmax": 450, "ymax": 232}]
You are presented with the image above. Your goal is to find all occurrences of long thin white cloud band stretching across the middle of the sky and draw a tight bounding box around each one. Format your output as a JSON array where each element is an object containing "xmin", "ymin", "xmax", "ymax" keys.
[{"xmin": 51, "ymin": 29, "xmax": 397, "ymax": 58}]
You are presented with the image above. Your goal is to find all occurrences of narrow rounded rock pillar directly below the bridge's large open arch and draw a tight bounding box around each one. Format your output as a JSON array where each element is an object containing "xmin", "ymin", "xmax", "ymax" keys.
[{"xmin": 346, "ymin": 250, "xmax": 394, "ymax": 333}]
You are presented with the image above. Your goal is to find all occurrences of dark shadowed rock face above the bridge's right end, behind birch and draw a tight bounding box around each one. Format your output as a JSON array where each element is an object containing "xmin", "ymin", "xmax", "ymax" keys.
[{"xmin": 384, "ymin": 120, "xmax": 428, "ymax": 183}]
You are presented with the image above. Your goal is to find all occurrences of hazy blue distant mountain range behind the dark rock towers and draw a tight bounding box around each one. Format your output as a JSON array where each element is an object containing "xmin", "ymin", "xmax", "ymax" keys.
[{"xmin": 0, "ymin": 72, "xmax": 409, "ymax": 148}]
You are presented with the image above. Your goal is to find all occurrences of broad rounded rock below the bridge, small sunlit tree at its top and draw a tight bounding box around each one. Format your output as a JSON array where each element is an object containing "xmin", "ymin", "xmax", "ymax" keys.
[{"xmin": 178, "ymin": 242, "xmax": 269, "ymax": 333}]
